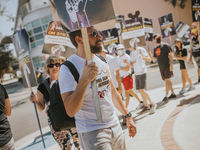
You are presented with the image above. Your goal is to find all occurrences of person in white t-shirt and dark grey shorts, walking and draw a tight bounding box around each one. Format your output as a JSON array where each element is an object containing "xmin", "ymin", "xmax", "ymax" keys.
[{"xmin": 124, "ymin": 46, "xmax": 157, "ymax": 114}]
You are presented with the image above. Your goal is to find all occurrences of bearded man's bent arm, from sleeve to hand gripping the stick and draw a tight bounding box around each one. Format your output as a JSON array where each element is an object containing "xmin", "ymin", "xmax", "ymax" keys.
[{"xmin": 61, "ymin": 62, "xmax": 98, "ymax": 117}]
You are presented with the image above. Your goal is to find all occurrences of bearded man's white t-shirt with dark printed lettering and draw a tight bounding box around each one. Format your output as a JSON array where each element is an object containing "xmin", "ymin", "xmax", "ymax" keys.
[{"xmin": 59, "ymin": 54, "xmax": 119, "ymax": 133}]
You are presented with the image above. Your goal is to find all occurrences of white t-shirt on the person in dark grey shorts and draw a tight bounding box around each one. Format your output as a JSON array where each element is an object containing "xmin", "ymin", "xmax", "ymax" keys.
[{"xmin": 130, "ymin": 47, "xmax": 148, "ymax": 75}]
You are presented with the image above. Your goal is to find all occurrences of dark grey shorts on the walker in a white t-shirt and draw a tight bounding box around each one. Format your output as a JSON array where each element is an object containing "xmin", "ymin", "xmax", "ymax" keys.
[{"xmin": 135, "ymin": 73, "xmax": 147, "ymax": 90}]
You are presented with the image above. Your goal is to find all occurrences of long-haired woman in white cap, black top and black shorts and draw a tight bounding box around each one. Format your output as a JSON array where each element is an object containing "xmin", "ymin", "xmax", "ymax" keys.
[{"xmin": 174, "ymin": 38, "xmax": 195, "ymax": 94}]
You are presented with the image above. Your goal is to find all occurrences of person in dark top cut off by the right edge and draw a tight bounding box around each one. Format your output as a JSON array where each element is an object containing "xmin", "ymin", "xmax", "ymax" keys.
[{"xmin": 190, "ymin": 22, "xmax": 200, "ymax": 82}]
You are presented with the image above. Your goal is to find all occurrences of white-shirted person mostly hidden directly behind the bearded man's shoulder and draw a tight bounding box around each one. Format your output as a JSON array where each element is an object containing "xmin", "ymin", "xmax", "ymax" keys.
[{"xmin": 101, "ymin": 45, "xmax": 122, "ymax": 94}]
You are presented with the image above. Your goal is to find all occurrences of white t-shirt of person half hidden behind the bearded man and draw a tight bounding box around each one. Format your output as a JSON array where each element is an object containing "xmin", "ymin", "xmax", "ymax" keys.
[{"xmin": 106, "ymin": 54, "xmax": 120, "ymax": 88}]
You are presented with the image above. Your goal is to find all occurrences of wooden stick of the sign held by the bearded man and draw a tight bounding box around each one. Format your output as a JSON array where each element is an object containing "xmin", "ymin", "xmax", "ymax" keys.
[{"xmin": 81, "ymin": 27, "xmax": 103, "ymax": 122}]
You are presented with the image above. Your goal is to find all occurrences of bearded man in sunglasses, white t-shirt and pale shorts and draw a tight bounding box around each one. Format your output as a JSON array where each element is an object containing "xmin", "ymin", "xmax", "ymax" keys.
[{"xmin": 59, "ymin": 26, "xmax": 136, "ymax": 150}]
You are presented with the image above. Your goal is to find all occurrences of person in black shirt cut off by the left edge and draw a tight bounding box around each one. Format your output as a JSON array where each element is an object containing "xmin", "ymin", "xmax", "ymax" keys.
[{"xmin": 0, "ymin": 83, "xmax": 15, "ymax": 150}]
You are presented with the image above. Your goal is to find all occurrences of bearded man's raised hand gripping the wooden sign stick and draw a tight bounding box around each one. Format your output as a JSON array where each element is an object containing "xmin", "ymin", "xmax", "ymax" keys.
[{"xmin": 81, "ymin": 62, "xmax": 98, "ymax": 84}]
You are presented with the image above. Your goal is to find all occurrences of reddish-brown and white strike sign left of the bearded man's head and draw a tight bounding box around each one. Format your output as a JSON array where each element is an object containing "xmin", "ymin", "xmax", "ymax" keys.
[{"xmin": 42, "ymin": 21, "xmax": 75, "ymax": 58}]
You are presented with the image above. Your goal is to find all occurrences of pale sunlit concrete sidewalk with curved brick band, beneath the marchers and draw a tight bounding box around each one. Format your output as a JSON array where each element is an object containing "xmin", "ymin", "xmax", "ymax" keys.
[{"xmin": 15, "ymin": 81, "xmax": 200, "ymax": 150}]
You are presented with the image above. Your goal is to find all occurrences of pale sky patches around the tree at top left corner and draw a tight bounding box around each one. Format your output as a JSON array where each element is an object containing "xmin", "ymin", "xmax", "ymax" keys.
[{"xmin": 0, "ymin": 0, "xmax": 18, "ymax": 57}]
